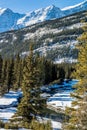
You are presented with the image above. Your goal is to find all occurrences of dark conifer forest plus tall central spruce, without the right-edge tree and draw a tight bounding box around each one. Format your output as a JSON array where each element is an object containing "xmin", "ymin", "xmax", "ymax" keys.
[{"xmin": 0, "ymin": 45, "xmax": 75, "ymax": 130}]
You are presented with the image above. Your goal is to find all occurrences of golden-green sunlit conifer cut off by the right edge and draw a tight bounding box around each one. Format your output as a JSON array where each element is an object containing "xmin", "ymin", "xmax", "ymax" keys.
[{"xmin": 63, "ymin": 23, "xmax": 87, "ymax": 130}]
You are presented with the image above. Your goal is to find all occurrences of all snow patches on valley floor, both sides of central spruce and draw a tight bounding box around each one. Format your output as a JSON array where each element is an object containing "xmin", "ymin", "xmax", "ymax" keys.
[{"xmin": 0, "ymin": 80, "xmax": 78, "ymax": 130}]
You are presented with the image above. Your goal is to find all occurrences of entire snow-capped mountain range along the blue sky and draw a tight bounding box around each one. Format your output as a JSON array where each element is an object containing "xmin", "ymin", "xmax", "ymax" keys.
[{"xmin": 0, "ymin": 0, "xmax": 87, "ymax": 32}]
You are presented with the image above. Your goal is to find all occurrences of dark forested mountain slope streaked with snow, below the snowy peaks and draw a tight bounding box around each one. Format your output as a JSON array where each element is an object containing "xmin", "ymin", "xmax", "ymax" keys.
[{"xmin": 0, "ymin": 11, "xmax": 87, "ymax": 63}]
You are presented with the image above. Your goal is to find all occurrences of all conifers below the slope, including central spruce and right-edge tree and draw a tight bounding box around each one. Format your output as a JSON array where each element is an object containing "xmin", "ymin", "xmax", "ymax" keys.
[{"xmin": 0, "ymin": 26, "xmax": 87, "ymax": 130}]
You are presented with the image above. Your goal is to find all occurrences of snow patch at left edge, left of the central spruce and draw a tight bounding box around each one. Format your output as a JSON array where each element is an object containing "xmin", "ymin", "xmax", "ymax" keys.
[{"xmin": 0, "ymin": 91, "xmax": 22, "ymax": 122}]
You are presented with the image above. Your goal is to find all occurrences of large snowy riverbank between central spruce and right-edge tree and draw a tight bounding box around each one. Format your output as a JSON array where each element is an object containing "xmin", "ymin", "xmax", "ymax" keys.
[{"xmin": 47, "ymin": 80, "xmax": 78, "ymax": 110}]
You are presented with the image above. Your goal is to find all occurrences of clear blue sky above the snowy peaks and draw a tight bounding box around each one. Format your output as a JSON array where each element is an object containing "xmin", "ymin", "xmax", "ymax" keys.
[{"xmin": 0, "ymin": 0, "xmax": 84, "ymax": 13}]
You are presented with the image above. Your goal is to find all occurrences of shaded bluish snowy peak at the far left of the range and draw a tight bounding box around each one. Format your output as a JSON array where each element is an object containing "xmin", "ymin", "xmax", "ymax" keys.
[{"xmin": 0, "ymin": 8, "xmax": 24, "ymax": 32}]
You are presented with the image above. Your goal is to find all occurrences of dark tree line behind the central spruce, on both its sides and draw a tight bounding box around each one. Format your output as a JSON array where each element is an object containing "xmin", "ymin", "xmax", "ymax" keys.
[{"xmin": 0, "ymin": 52, "xmax": 74, "ymax": 95}]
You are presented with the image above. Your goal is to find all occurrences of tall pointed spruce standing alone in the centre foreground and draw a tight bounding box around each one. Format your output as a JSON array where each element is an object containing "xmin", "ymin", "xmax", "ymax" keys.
[{"xmin": 17, "ymin": 47, "xmax": 44, "ymax": 128}]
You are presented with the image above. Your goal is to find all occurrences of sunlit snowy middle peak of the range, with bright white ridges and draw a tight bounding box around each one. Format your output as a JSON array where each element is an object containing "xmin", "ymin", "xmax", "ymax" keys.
[{"xmin": 17, "ymin": 5, "xmax": 64, "ymax": 27}]
